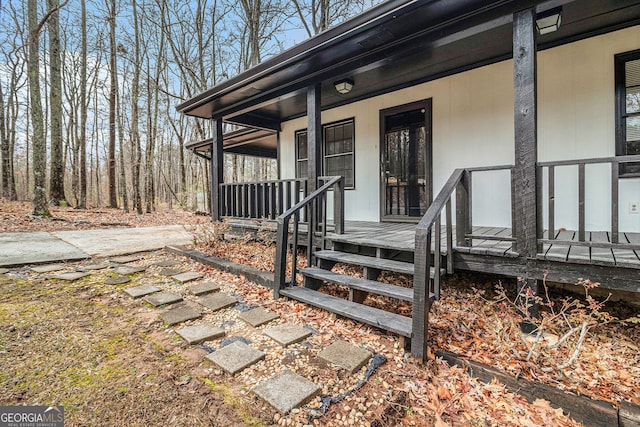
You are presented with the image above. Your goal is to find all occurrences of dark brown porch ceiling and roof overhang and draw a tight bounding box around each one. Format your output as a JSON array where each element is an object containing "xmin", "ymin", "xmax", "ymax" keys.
[{"xmin": 178, "ymin": 0, "xmax": 640, "ymax": 130}]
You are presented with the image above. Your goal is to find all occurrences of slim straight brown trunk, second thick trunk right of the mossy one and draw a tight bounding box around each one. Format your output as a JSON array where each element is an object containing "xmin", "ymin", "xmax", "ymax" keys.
[{"xmin": 107, "ymin": 0, "xmax": 118, "ymax": 208}]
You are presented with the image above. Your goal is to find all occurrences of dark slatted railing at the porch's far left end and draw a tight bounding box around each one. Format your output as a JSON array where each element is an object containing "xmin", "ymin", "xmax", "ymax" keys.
[{"xmin": 220, "ymin": 178, "xmax": 307, "ymax": 219}]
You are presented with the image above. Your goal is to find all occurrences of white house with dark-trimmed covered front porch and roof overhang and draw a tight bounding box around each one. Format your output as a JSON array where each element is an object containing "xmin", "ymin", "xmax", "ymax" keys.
[{"xmin": 178, "ymin": 0, "xmax": 640, "ymax": 356}]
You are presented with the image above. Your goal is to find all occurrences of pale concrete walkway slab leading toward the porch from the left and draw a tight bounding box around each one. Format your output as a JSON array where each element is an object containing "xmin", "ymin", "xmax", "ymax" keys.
[{"xmin": 0, "ymin": 225, "xmax": 192, "ymax": 266}]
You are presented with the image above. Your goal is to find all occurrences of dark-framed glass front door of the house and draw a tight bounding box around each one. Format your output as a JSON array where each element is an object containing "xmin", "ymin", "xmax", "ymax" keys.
[{"xmin": 380, "ymin": 99, "xmax": 433, "ymax": 222}]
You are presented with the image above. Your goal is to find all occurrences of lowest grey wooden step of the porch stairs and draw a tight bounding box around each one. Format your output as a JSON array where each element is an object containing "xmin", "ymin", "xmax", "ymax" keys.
[{"xmin": 280, "ymin": 286, "xmax": 411, "ymax": 337}]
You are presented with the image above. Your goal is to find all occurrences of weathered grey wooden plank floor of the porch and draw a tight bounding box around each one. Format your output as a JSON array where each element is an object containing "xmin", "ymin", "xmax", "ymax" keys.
[{"xmin": 225, "ymin": 219, "xmax": 640, "ymax": 269}]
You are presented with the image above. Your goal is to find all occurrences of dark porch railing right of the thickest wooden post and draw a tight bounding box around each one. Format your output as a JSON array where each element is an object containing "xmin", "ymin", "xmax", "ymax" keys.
[{"xmin": 537, "ymin": 155, "xmax": 640, "ymax": 250}]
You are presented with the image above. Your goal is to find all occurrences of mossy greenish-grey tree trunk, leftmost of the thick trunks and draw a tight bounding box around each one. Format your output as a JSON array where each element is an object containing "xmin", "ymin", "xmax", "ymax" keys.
[{"xmin": 27, "ymin": 0, "xmax": 51, "ymax": 216}]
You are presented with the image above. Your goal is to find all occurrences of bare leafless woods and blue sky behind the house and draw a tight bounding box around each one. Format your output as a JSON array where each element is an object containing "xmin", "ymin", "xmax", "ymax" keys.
[{"xmin": 0, "ymin": 0, "xmax": 380, "ymax": 216}]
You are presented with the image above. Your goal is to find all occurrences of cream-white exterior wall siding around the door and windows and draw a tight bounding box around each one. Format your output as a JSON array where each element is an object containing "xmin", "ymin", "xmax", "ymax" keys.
[{"xmin": 281, "ymin": 26, "xmax": 640, "ymax": 231}]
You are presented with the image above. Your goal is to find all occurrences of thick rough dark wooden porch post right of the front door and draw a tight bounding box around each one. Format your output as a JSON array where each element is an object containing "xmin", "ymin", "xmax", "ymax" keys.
[{"xmin": 513, "ymin": 8, "xmax": 538, "ymax": 332}]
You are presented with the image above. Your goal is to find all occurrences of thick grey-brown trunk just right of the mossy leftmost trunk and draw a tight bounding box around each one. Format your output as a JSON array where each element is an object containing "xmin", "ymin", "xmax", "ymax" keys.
[{"xmin": 47, "ymin": 0, "xmax": 65, "ymax": 205}]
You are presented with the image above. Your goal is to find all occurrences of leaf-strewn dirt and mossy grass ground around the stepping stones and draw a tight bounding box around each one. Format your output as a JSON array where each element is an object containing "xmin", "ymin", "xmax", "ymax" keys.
[{"xmin": 0, "ymin": 203, "xmax": 639, "ymax": 427}]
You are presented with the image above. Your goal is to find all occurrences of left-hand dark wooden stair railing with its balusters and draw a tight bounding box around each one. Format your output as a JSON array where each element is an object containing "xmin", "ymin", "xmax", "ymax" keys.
[{"xmin": 273, "ymin": 176, "xmax": 344, "ymax": 298}]
